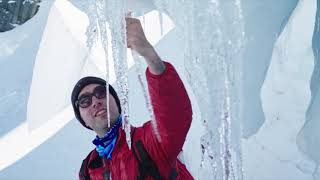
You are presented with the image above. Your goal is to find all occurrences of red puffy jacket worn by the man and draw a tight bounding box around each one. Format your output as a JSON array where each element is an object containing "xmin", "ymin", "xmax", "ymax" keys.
[{"xmin": 80, "ymin": 62, "xmax": 193, "ymax": 180}]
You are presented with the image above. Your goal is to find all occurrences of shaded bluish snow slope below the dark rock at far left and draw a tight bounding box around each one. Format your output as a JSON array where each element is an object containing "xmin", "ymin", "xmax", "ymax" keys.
[{"xmin": 0, "ymin": 1, "xmax": 53, "ymax": 136}]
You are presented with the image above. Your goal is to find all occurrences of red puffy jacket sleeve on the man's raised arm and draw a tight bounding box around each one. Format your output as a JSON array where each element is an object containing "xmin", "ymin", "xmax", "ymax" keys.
[{"xmin": 146, "ymin": 62, "xmax": 192, "ymax": 160}]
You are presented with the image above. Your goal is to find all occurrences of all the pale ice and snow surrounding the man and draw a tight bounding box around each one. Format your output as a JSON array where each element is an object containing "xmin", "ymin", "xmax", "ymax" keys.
[{"xmin": 0, "ymin": 0, "xmax": 320, "ymax": 180}]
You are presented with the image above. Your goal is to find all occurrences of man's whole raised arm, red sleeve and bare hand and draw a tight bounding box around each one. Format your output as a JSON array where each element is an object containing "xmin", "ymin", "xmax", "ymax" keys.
[{"xmin": 126, "ymin": 18, "xmax": 192, "ymax": 161}]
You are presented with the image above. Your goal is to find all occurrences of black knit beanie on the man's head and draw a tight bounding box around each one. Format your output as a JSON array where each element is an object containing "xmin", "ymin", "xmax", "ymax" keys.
[{"xmin": 71, "ymin": 76, "xmax": 121, "ymax": 130}]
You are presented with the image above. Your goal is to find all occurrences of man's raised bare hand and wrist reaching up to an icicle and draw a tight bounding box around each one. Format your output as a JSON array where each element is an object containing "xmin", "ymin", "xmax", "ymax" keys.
[{"xmin": 126, "ymin": 17, "xmax": 165, "ymax": 74}]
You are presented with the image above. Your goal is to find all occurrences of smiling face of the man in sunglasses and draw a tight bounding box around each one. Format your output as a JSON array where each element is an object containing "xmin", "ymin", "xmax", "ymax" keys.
[{"xmin": 78, "ymin": 84, "xmax": 119, "ymax": 132}]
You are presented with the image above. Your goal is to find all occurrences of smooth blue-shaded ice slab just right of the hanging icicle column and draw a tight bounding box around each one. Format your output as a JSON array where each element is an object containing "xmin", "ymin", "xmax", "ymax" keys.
[{"xmin": 242, "ymin": 0, "xmax": 298, "ymax": 138}]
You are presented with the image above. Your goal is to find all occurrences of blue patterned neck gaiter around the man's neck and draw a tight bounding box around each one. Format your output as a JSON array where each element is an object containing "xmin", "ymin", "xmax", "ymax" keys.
[{"xmin": 92, "ymin": 115, "xmax": 122, "ymax": 160}]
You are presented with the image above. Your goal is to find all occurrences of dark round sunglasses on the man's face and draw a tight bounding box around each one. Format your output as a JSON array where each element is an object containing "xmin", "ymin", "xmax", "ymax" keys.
[{"xmin": 75, "ymin": 86, "xmax": 106, "ymax": 108}]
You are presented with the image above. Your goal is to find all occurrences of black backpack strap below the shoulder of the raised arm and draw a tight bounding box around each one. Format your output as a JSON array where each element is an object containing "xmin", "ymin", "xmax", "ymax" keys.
[{"xmin": 131, "ymin": 128, "xmax": 178, "ymax": 180}]
